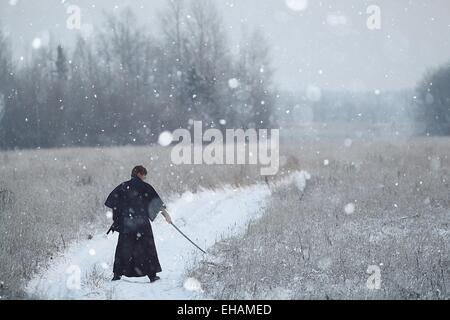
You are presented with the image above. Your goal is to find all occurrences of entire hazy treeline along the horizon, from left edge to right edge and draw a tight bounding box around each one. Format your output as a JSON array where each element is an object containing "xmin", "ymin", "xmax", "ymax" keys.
[{"xmin": 0, "ymin": 0, "xmax": 450, "ymax": 149}]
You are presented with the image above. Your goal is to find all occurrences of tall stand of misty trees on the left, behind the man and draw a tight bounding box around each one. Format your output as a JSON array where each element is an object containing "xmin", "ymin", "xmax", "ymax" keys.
[{"xmin": 0, "ymin": 0, "xmax": 276, "ymax": 148}]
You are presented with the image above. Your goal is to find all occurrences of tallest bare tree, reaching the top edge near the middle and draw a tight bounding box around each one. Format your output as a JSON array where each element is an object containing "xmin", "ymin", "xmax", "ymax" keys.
[{"xmin": 184, "ymin": 0, "xmax": 231, "ymax": 126}]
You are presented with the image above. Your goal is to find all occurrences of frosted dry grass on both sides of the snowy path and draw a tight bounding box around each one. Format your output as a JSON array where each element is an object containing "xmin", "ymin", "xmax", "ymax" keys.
[{"xmin": 0, "ymin": 138, "xmax": 450, "ymax": 298}]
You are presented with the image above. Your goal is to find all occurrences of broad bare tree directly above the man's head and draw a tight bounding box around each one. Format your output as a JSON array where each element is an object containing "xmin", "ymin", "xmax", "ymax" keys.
[{"xmin": 98, "ymin": 9, "xmax": 161, "ymax": 143}]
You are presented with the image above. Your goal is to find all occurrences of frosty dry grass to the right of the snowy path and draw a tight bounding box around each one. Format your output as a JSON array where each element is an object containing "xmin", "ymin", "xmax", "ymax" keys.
[{"xmin": 188, "ymin": 138, "xmax": 450, "ymax": 299}]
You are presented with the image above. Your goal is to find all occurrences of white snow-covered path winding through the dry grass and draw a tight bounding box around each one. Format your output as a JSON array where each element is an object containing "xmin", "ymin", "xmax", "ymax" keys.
[{"xmin": 26, "ymin": 171, "xmax": 309, "ymax": 300}]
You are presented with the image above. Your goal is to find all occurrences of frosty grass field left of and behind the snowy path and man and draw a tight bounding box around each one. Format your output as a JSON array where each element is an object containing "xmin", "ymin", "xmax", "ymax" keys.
[{"xmin": 0, "ymin": 146, "xmax": 297, "ymax": 299}]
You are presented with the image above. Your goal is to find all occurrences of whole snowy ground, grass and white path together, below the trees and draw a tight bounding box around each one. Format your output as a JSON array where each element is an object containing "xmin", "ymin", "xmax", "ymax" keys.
[{"xmin": 0, "ymin": 138, "xmax": 450, "ymax": 299}]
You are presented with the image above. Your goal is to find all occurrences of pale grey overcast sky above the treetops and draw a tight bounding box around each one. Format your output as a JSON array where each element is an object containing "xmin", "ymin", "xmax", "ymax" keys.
[{"xmin": 0, "ymin": 0, "xmax": 450, "ymax": 90}]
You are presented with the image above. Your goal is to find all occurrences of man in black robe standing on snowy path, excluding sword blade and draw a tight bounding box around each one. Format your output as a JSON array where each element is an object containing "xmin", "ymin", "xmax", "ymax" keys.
[{"xmin": 105, "ymin": 166, "xmax": 172, "ymax": 282}]
